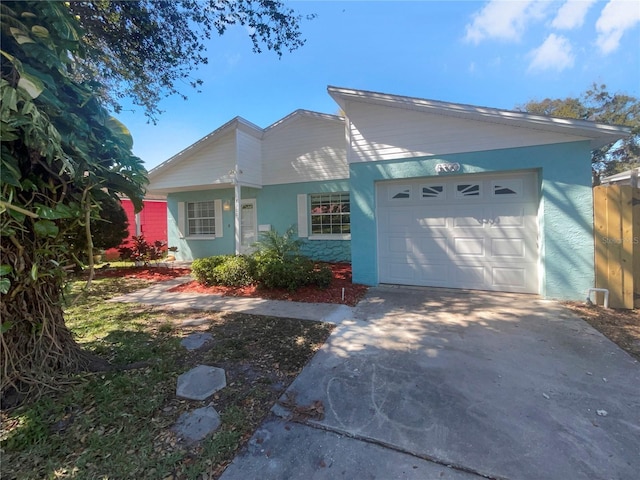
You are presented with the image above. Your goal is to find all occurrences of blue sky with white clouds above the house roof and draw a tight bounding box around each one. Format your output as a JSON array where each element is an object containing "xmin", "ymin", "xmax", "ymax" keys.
[{"xmin": 117, "ymin": 0, "xmax": 640, "ymax": 170}]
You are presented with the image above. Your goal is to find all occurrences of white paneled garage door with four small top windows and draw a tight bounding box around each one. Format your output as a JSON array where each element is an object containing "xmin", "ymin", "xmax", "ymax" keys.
[{"xmin": 376, "ymin": 173, "xmax": 538, "ymax": 293}]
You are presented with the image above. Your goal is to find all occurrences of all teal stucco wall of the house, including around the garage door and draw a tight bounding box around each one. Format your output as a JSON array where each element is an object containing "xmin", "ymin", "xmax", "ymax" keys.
[{"xmin": 167, "ymin": 142, "xmax": 594, "ymax": 299}]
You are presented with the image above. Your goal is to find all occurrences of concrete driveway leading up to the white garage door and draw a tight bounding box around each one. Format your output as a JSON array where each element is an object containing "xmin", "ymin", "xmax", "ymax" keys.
[{"xmin": 222, "ymin": 287, "xmax": 640, "ymax": 480}]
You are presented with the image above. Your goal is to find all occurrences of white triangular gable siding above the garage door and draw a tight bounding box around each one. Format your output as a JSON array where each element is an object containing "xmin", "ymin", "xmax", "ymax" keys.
[{"xmin": 349, "ymin": 103, "xmax": 592, "ymax": 162}]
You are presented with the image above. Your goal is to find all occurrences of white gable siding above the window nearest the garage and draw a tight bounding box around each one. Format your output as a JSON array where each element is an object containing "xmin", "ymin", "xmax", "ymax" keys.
[{"xmin": 262, "ymin": 115, "xmax": 349, "ymax": 185}]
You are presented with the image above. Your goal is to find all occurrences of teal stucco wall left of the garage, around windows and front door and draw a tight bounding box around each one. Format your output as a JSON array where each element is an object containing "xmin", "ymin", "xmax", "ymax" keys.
[{"xmin": 167, "ymin": 180, "xmax": 351, "ymax": 262}]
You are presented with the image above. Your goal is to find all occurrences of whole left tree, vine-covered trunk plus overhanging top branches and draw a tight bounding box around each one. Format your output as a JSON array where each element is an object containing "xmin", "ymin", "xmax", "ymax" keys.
[{"xmin": 0, "ymin": 0, "xmax": 310, "ymax": 405}]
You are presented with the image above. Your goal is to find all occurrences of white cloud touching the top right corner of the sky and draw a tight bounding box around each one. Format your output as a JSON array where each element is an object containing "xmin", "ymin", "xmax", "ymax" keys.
[{"xmin": 596, "ymin": 0, "xmax": 640, "ymax": 54}]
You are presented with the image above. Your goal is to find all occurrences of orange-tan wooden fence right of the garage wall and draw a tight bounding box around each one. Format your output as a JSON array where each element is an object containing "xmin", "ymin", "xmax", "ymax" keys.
[{"xmin": 593, "ymin": 185, "xmax": 640, "ymax": 308}]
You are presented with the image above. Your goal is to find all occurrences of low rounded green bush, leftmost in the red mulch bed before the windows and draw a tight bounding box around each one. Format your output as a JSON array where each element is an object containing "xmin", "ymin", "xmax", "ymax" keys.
[{"xmin": 191, "ymin": 255, "xmax": 255, "ymax": 287}]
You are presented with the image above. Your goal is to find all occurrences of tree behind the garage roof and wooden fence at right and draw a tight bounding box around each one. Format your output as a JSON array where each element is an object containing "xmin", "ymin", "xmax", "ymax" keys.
[{"xmin": 516, "ymin": 84, "xmax": 640, "ymax": 176}]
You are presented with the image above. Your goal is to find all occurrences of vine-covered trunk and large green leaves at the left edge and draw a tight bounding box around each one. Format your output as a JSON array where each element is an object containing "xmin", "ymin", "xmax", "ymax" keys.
[{"xmin": 0, "ymin": 2, "xmax": 146, "ymax": 404}]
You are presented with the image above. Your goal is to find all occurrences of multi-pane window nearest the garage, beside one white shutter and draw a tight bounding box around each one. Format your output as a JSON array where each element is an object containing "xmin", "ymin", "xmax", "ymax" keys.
[{"xmin": 310, "ymin": 193, "xmax": 351, "ymax": 235}]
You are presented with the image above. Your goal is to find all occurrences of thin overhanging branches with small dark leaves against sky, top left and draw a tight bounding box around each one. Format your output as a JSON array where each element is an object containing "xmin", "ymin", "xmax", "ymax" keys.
[{"xmin": 69, "ymin": 0, "xmax": 304, "ymax": 120}]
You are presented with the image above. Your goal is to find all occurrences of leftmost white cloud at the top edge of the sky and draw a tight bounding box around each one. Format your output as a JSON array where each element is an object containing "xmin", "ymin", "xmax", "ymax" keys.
[{"xmin": 465, "ymin": 0, "xmax": 541, "ymax": 44}]
